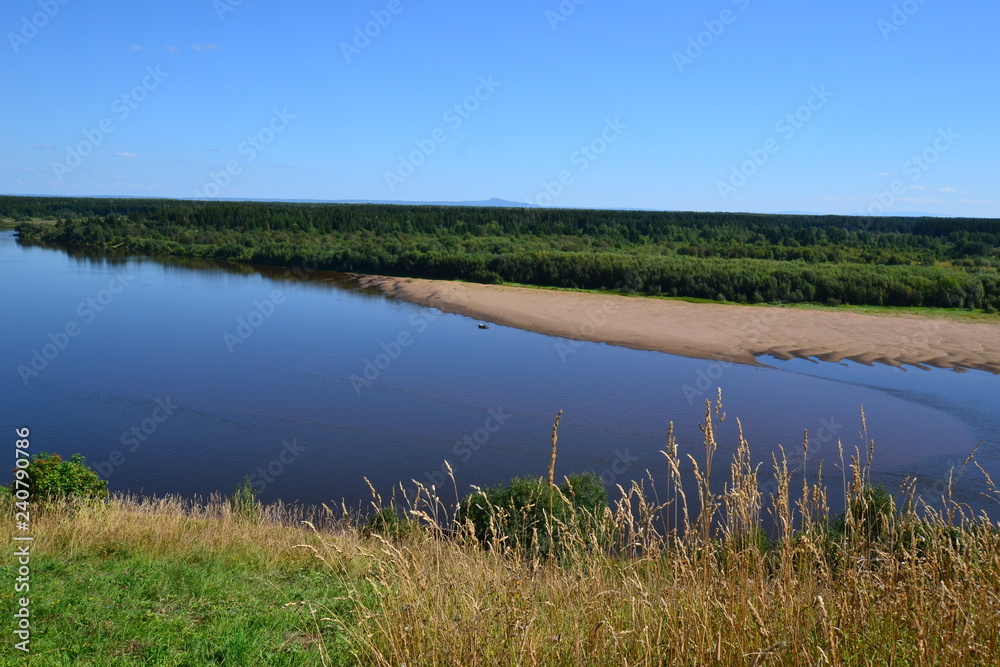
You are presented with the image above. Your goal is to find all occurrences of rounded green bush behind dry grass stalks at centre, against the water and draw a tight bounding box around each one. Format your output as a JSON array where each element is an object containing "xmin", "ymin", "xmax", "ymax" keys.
[{"xmin": 458, "ymin": 473, "xmax": 609, "ymax": 557}]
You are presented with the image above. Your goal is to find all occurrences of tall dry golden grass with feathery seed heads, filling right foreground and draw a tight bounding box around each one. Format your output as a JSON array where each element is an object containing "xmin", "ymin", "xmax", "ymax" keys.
[{"xmin": 304, "ymin": 400, "xmax": 1000, "ymax": 665}]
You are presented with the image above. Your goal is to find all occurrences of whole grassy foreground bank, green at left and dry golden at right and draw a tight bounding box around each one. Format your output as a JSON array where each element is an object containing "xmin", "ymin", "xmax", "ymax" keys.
[{"xmin": 7, "ymin": 406, "xmax": 1000, "ymax": 666}]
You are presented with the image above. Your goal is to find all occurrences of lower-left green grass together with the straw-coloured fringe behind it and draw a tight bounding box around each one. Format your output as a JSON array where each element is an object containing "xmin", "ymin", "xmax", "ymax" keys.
[{"xmin": 0, "ymin": 499, "xmax": 368, "ymax": 666}]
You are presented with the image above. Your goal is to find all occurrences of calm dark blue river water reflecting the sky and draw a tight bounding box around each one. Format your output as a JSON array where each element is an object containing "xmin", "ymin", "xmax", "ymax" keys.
[{"xmin": 0, "ymin": 232, "xmax": 1000, "ymax": 515}]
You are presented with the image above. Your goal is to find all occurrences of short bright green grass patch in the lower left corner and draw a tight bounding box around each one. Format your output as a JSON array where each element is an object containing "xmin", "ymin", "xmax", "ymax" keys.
[{"xmin": 1, "ymin": 543, "xmax": 336, "ymax": 665}]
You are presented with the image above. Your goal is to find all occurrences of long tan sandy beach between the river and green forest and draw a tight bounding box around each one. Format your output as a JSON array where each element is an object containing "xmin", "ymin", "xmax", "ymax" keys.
[{"xmin": 358, "ymin": 276, "xmax": 1000, "ymax": 374}]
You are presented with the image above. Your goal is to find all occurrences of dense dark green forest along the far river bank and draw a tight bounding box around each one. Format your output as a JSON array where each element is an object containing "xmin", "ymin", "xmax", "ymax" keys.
[{"xmin": 7, "ymin": 197, "xmax": 1000, "ymax": 312}]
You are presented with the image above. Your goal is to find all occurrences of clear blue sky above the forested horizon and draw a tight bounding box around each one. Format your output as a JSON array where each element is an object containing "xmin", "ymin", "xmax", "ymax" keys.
[{"xmin": 0, "ymin": 0, "xmax": 1000, "ymax": 217}]
